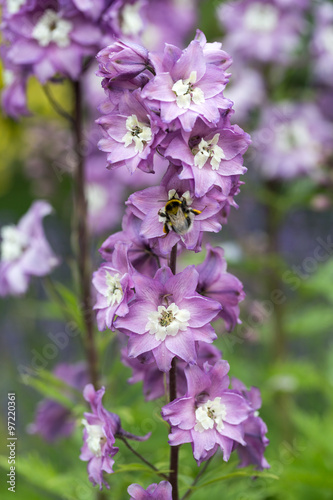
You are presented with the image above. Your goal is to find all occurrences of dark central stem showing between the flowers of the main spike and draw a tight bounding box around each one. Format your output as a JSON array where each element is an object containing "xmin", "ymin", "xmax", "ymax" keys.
[{"xmin": 169, "ymin": 244, "xmax": 179, "ymax": 500}]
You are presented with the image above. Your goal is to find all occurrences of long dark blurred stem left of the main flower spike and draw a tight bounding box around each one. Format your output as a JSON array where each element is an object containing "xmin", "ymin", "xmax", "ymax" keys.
[{"xmin": 73, "ymin": 81, "xmax": 98, "ymax": 388}]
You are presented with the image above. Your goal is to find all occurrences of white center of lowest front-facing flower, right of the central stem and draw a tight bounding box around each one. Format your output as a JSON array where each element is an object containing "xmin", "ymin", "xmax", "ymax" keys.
[{"xmin": 194, "ymin": 397, "xmax": 227, "ymax": 432}]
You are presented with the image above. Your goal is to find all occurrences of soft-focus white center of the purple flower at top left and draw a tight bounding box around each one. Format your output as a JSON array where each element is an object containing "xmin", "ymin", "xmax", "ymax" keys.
[{"xmin": 32, "ymin": 9, "xmax": 73, "ymax": 48}]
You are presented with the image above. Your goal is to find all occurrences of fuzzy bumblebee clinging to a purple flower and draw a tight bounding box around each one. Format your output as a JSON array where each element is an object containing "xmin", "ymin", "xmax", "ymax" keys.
[{"xmin": 158, "ymin": 190, "xmax": 201, "ymax": 236}]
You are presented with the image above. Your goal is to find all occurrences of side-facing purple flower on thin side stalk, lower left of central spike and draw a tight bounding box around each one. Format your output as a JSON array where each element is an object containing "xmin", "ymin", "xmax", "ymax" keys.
[{"xmin": 80, "ymin": 384, "xmax": 150, "ymax": 489}]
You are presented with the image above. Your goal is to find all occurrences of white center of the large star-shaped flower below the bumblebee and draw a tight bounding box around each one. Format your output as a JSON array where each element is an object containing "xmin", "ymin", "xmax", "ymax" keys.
[{"xmin": 145, "ymin": 302, "xmax": 191, "ymax": 340}]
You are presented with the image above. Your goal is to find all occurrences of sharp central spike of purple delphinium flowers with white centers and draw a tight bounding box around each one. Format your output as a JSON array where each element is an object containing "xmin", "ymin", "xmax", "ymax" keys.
[{"xmin": 87, "ymin": 31, "xmax": 267, "ymax": 490}]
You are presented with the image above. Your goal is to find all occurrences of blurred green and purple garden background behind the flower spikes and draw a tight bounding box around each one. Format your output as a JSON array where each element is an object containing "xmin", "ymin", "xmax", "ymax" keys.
[{"xmin": 0, "ymin": 0, "xmax": 333, "ymax": 500}]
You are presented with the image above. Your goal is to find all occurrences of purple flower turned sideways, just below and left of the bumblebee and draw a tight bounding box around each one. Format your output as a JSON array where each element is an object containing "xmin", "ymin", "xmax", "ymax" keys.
[{"xmin": 99, "ymin": 209, "xmax": 166, "ymax": 277}]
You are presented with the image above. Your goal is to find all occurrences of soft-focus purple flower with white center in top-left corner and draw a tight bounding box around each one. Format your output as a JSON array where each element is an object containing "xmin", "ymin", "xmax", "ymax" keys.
[{"xmin": 3, "ymin": 1, "xmax": 102, "ymax": 83}]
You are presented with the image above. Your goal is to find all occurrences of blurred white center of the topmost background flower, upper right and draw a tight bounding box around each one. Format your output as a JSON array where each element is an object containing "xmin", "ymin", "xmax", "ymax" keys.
[{"xmin": 244, "ymin": 2, "xmax": 279, "ymax": 33}]
